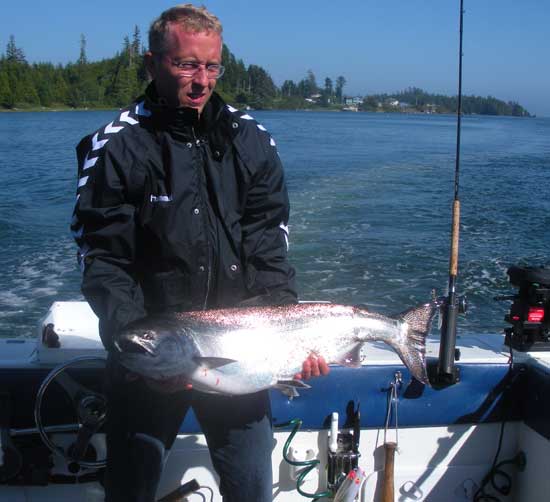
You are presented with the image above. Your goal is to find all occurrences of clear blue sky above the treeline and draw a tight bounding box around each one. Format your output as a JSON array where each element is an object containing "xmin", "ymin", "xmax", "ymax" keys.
[{"xmin": 0, "ymin": 0, "xmax": 550, "ymax": 116}]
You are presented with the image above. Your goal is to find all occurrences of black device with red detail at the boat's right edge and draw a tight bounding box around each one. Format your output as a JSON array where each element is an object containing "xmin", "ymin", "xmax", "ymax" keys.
[{"xmin": 495, "ymin": 266, "xmax": 550, "ymax": 352}]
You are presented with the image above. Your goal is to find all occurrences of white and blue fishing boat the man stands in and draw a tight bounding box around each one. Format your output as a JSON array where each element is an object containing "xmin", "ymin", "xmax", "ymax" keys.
[{"xmin": 0, "ymin": 267, "xmax": 550, "ymax": 502}]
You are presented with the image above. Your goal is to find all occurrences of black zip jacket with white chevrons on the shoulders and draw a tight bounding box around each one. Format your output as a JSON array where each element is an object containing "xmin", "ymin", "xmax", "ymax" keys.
[{"xmin": 71, "ymin": 84, "xmax": 296, "ymax": 348}]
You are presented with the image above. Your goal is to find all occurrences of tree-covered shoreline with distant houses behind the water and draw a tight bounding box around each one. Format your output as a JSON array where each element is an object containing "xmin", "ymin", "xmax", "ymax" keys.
[{"xmin": 0, "ymin": 31, "xmax": 530, "ymax": 117}]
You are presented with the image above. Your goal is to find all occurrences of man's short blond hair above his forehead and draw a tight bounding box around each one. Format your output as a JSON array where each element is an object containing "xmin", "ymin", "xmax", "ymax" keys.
[{"xmin": 149, "ymin": 3, "xmax": 223, "ymax": 53}]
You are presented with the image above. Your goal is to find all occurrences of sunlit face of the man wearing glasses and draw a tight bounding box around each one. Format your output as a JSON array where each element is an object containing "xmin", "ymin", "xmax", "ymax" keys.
[{"xmin": 149, "ymin": 24, "xmax": 222, "ymax": 113}]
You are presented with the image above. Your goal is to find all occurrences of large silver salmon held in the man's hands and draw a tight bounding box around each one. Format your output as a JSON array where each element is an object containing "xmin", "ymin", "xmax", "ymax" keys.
[{"xmin": 115, "ymin": 301, "xmax": 438, "ymax": 395}]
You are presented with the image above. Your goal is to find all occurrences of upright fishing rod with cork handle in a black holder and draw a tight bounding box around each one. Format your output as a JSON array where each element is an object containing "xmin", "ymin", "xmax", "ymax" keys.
[{"xmin": 437, "ymin": 0, "xmax": 466, "ymax": 384}]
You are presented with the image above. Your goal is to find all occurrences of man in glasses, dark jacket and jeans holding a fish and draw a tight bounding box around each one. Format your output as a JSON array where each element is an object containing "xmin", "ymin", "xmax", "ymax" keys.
[{"xmin": 72, "ymin": 4, "xmax": 328, "ymax": 502}]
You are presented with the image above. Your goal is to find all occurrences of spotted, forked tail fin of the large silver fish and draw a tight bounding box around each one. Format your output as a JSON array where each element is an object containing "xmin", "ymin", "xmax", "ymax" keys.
[{"xmin": 390, "ymin": 301, "xmax": 438, "ymax": 385}]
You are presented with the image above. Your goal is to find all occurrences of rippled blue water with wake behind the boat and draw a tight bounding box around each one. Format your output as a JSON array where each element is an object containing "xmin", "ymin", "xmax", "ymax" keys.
[{"xmin": 0, "ymin": 111, "xmax": 550, "ymax": 337}]
